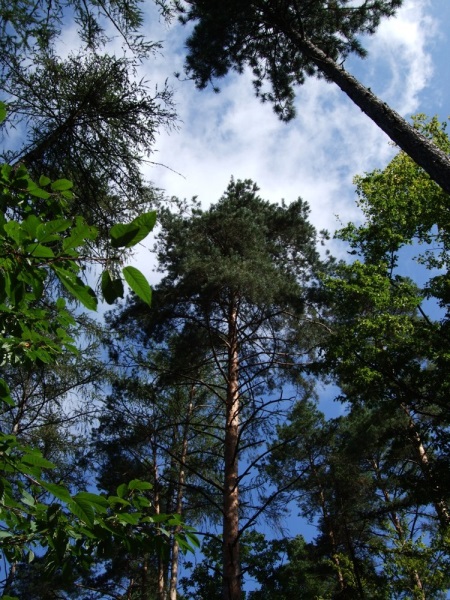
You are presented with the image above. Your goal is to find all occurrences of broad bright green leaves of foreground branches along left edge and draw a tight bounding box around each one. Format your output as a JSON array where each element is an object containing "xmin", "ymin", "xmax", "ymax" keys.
[{"xmin": 0, "ymin": 105, "xmax": 195, "ymax": 598}]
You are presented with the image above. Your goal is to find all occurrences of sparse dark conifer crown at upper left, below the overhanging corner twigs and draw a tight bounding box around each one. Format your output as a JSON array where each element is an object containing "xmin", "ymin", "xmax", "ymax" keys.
[{"xmin": 3, "ymin": 51, "xmax": 175, "ymax": 240}]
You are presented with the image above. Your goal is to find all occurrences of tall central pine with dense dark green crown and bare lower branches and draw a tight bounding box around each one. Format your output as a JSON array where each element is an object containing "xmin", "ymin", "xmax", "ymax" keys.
[{"xmin": 104, "ymin": 180, "xmax": 332, "ymax": 598}]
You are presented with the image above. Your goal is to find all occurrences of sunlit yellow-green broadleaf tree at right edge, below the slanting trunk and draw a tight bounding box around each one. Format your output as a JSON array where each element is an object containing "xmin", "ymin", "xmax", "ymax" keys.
[{"xmin": 318, "ymin": 120, "xmax": 450, "ymax": 530}]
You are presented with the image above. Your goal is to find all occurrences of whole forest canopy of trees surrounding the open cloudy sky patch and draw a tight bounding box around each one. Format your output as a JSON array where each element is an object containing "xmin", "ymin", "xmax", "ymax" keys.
[{"xmin": 0, "ymin": 0, "xmax": 450, "ymax": 600}]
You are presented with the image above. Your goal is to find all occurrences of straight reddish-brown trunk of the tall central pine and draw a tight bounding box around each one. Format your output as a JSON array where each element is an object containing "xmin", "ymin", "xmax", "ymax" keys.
[{"xmin": 223, "ymin": 298, "xmax": 241, "ymax": 600}]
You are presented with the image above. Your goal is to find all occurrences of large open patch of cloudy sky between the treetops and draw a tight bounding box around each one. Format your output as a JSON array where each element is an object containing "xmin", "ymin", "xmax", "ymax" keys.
[{"xmin": 127, "ymin": 0, "xmax": 450, "ymax": 274}]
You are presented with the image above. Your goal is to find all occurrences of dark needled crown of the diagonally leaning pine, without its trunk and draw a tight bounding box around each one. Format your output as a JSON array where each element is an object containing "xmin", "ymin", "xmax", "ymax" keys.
[{"xmin": 175, "ymin": 0, "xmax": 402, "ymax": 120}]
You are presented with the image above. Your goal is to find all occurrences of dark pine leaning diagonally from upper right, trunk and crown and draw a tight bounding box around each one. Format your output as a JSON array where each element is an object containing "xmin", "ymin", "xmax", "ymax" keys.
[{"xmin": 175, "ymin": 0, "xmax": 450, "ymax": 193}]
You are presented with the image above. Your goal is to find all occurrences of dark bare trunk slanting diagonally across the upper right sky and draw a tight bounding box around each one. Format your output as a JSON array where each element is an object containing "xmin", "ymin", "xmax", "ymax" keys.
[{"xmin": 282, "ymin": 25, "xmax": 450, "ymax": 194}]
